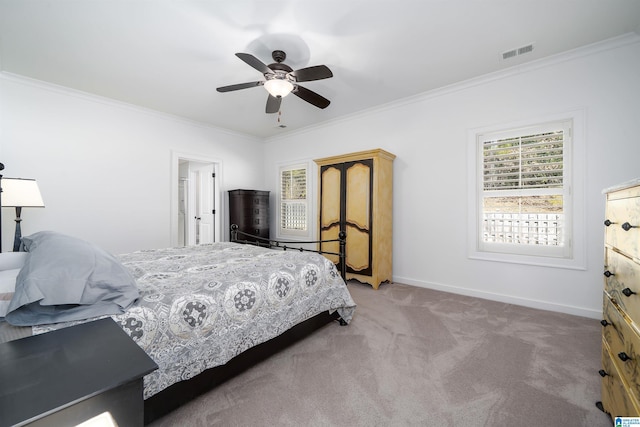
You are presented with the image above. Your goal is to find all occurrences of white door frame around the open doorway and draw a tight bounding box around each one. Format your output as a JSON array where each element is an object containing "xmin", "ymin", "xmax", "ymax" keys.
[{"xmin": 169, "ymin": 151, "xmax": 226, "ymax": 247}]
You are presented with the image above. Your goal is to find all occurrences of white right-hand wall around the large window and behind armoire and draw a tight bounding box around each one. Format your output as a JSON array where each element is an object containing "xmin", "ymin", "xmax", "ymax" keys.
[{"xmin": 265, "ymin": 36, "xmax": 640, "ymax": 318}]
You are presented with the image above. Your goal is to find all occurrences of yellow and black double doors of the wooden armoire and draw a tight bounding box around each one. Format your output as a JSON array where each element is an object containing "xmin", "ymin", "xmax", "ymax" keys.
[{"xmin": 320, "ymin": 159, "xmax": 373, "ymax": 276}]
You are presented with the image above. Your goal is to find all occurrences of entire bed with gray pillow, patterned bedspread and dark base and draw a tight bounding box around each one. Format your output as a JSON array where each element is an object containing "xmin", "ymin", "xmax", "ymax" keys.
[{"xmin": 3, "ymin": 229, "xmax": 355, "ymax": 423}]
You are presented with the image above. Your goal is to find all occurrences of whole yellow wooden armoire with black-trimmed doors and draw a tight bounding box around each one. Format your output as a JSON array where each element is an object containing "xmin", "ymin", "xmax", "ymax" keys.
[{"xmin": 314, "ymin": 149, "xmax": 396, "ymax": 289}]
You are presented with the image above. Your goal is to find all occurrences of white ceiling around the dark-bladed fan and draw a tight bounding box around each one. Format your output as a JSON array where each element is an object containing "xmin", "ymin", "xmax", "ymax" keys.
[{"xmin": 0, "ymin": 0, "xmax": 640, "ymax": 138}]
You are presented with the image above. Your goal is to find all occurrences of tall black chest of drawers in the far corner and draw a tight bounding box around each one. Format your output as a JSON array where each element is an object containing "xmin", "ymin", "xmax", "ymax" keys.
[{"xmin": 229, "ymin": 190, "xmax": 269, "ymax": 241}]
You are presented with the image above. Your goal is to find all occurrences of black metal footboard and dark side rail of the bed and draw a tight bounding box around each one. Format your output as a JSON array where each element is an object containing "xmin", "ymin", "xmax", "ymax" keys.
[{"xmin": 144, "ymin": 224, "xmax": 346, "ymax": 425}]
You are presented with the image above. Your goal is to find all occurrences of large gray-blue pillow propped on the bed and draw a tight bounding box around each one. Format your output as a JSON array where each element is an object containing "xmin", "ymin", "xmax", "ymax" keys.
[{"xmin": 5, "ymin": 231, "xmax": 140, "ymax": 326}]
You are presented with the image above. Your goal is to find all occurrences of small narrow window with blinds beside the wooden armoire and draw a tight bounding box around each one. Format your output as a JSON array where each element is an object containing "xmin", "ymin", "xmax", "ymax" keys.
[{"xmin": 279, "ymin": 164, "xmax": 309, "ymax": 236}]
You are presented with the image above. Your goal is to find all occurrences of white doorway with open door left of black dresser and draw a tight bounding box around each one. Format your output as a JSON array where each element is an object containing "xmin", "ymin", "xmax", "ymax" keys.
[{"xmin": 171, "ymin": 155, "xmax": 222, "ymax": 246}]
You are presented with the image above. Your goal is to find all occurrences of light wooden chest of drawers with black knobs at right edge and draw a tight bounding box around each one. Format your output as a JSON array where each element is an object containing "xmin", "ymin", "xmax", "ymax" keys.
[{"xmin": 599, "ymin": 180, "xmax": 640, "ymax": 417}]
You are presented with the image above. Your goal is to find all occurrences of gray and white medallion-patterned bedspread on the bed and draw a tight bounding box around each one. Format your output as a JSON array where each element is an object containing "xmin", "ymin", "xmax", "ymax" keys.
[{"xmin": 33, "ymin": 243, "xmax": 355, "ymax": 399}]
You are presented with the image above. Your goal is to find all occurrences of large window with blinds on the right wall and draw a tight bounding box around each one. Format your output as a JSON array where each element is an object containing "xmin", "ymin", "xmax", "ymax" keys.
[{"xmin": 476, "ymin": 120, "xmax": 573, "ymax": 258}]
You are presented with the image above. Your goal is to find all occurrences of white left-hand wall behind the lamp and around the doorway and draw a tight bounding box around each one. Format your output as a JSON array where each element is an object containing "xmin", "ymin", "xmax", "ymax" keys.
[{"xmin": 0, "ymin": 73, "xmax": 264, "ymax": 253}]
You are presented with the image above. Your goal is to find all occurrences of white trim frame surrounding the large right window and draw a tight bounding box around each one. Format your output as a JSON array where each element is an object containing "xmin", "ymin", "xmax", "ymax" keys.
[{"xmin": 468, "ymin": 111, "xmax": 586, "ymax": 269}]
